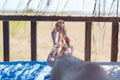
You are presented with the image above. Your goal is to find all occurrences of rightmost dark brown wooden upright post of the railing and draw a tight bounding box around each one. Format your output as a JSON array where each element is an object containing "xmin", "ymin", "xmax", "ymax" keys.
[{"xmin": 111, "ymin": 20, "xmax": 119, "ymax": 62}]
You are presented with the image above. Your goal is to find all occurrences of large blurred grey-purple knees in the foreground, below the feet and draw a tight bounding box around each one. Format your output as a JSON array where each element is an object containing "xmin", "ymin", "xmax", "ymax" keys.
[{"xmin": 50, "ymin": 55, "xmax": 111, "ymax": 80}]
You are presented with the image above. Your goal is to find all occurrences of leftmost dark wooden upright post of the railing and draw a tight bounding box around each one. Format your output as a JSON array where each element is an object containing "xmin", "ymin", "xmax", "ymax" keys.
[{"xmin": 3, "ymin": 21, "xmax": 9, "ymax": 61}]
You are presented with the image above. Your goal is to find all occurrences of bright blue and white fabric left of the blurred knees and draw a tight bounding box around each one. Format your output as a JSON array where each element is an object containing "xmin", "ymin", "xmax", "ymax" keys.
[{"xmin": 0, "ymin": 61, "xmax": 51, "ymax": 80}]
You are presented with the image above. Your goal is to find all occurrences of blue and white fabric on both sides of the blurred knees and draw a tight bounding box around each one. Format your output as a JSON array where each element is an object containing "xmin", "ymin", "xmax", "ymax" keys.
[{"xmin": 0, "ymin": 61, "xmax": 120, "ymax": 80}]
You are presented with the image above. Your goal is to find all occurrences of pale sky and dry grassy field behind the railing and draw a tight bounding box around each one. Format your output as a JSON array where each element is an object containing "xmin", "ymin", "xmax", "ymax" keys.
[{"xmin": 0, "ymin": 0, "xmax": 120, "ymax": 62}]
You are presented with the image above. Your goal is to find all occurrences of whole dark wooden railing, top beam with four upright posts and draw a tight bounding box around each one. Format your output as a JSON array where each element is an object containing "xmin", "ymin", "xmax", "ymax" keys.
[{"xmin": 0, "ymin": 15, "xmax": 120, "ymax": 62}]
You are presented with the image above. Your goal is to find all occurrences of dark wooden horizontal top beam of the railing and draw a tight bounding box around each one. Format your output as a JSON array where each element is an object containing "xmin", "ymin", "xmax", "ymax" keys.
[{"xmin": 0, "ymin": 15, "xmax": 120, "ymax": 22}]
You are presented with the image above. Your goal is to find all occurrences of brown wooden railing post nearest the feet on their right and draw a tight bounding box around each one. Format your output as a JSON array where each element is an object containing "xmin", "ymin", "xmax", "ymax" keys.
[{"xmin": 85, "ymin": 22, "xmax": 92, "ymax": 61}]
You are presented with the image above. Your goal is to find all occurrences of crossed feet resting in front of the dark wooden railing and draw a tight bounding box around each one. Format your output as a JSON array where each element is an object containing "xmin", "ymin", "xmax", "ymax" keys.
[{"xmin": 47, "ymin": 20, "xmax": 73, "ymax": 67}]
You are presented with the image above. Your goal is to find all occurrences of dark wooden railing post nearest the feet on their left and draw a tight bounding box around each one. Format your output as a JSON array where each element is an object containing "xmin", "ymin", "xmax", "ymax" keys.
[{"xmin": 31, "ymin": 21, "xmax": 37, "ymax": 60}]
